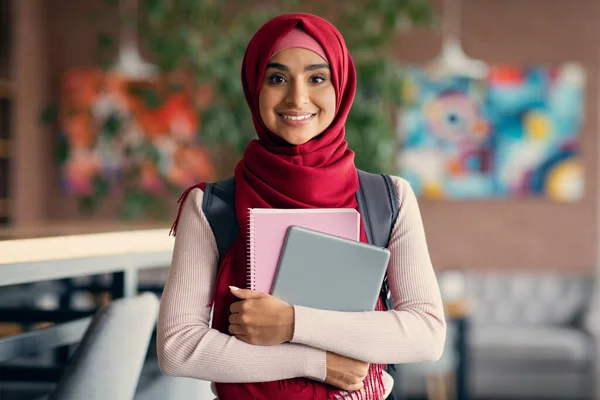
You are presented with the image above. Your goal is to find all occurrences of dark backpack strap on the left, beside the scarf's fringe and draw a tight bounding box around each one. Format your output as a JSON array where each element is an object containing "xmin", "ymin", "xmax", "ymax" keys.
[{"xmin": 202, "ymin": 178, "xmax": 239, "ymax": 260}]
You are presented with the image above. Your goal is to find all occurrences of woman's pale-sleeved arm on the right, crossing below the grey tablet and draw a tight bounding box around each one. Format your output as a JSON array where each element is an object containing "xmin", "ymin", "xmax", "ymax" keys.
[{"xmin": 292, "ymin": 177, "xmax": 446, "ymax": 364}]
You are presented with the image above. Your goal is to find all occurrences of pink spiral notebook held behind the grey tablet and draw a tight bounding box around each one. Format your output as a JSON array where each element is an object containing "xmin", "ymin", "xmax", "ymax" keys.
[{"xmin": 248, "ymin": 208, "xmax": 360, "ymax": 293}]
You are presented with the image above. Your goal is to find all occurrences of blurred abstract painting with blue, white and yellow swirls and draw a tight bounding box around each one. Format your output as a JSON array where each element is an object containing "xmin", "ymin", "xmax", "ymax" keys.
[{"xmin": 398, "ymin": 64, "xmax": 585, "ymax": 202}]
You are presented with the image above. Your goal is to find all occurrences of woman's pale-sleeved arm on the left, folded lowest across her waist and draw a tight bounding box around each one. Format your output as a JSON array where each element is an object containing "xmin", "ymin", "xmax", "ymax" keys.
[{"xmin": 158, "ymin": 189, "xmax": 326, "ymax": 383}]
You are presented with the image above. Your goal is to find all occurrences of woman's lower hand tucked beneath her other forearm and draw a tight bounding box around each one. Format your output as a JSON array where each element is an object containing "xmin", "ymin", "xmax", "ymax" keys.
[{"xmin": 325, "ymin": 352, "xmax": 369, "ymax": 392}]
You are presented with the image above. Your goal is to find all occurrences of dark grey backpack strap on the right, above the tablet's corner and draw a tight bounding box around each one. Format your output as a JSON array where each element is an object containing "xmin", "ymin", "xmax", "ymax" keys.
[{"xmin": 356, "ymin": 170, "xmax": 399, "ymax": 247}]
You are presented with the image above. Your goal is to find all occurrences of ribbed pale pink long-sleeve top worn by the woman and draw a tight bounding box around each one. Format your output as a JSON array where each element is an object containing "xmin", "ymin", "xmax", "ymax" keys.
[{"xmin": 158, "ymin": 177, "xmax": 446, "ymax": 388}]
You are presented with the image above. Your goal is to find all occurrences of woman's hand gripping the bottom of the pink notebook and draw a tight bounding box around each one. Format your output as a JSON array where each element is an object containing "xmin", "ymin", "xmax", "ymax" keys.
[{"xmin": 229, "ymin": 286, "xmax": 294, "ymax": 346}]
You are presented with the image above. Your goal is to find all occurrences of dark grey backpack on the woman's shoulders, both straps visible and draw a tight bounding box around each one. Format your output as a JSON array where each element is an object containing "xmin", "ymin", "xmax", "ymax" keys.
[{"xmin": 202, "ymin": 170, "xmax": 399, "ymax": 309}]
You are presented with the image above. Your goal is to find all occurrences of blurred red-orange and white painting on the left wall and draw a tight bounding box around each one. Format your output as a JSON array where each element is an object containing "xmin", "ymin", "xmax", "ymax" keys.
[{"xmin": 58, "ymin": 69, "xmax": 215, "ymax": 219}]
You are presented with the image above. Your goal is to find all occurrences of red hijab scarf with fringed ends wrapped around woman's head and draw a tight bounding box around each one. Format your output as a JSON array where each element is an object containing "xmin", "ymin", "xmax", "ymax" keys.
[{"xmin": 174, "ymin": 14, "xmax": 384, "ymax": 400}]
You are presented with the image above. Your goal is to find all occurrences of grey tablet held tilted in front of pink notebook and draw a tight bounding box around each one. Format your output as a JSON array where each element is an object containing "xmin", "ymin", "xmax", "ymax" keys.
[{"xmin": 271, "ymin": 226, "xmax": 390, "ymax": 312}]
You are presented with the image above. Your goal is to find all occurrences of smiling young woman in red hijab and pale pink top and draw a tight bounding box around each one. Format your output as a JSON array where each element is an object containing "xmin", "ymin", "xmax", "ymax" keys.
[{"xmin": 158, "ymin": 14, "xmax": 446, "ymax": 400}]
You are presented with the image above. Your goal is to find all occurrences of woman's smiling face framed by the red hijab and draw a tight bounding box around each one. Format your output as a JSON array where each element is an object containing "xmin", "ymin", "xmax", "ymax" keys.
[{"xmin": 259, "ymin": 47, "xmax": 336, "ymax": 145}]
